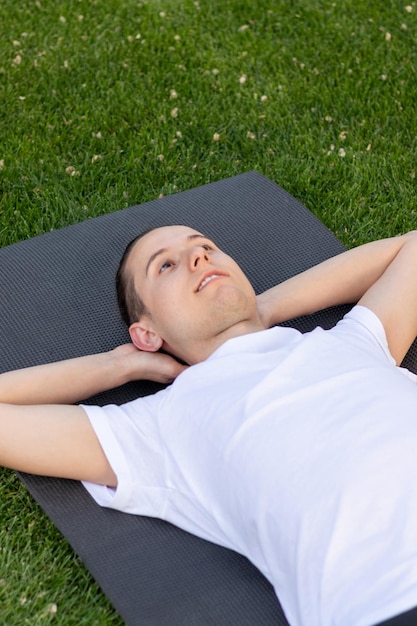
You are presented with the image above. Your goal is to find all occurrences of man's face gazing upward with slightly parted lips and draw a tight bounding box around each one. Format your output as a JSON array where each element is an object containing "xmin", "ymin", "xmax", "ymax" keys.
[{"xmin": 126, "ymin": 226, "xmax": 258, "ymax": 358}]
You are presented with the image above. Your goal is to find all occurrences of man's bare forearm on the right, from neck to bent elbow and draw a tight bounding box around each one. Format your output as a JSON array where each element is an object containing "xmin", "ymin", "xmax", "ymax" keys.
[{"xmin": 258, "ymin": 234, "xmax": 415, "ymax": 326}]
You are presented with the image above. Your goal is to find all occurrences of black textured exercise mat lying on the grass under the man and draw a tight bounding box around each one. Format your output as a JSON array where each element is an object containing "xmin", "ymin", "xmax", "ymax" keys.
[{"xmin": 0, "ymin": 172, "xmax": 417, "ymax": 626}]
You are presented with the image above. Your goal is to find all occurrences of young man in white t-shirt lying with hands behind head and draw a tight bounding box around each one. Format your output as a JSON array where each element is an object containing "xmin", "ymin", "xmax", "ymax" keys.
[{"xmin": 0, "ymin": 226, "xmax": 417, "ymax": 626}]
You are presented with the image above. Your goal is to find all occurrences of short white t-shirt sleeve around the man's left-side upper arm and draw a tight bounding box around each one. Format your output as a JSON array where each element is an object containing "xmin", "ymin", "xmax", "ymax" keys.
[{"xmin": 82, "ymin": 390, "xmax": 171, "ymax": 517}]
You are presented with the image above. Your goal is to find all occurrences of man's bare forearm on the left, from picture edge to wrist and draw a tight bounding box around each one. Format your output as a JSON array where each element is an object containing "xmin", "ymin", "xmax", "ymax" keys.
[{"xmin": 0, "ymin": 350, "xmax": 129, "ymax": 404}]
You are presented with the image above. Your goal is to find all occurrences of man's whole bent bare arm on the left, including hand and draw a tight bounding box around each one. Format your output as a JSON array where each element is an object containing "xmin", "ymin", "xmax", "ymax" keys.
[{"xmin": 0, "ymin": 344, "xmax": 184, "ymax": 486}]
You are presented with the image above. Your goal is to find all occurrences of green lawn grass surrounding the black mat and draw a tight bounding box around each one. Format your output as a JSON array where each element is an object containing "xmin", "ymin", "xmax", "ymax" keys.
[{"xmin": 0, "ymin": 0, "xmax": 417, "ymax": 626}]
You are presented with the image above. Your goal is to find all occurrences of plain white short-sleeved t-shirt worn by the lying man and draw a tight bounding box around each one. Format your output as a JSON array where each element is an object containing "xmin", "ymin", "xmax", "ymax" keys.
[{"xmin": 84, "ymin": 306, "xmax": 417, "ymax": 626}]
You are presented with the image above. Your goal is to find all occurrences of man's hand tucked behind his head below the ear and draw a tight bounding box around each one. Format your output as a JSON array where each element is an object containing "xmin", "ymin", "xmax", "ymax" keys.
[{"xmin": 113, "ymin": 343, "xmax": 188, "ymax": 384}]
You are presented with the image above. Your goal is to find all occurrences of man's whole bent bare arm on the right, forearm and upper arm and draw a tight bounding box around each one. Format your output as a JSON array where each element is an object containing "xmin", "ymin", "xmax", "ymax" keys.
[{"xmin": 258, "ymin": 231, "xmax": 417, "ymax": 362}]
